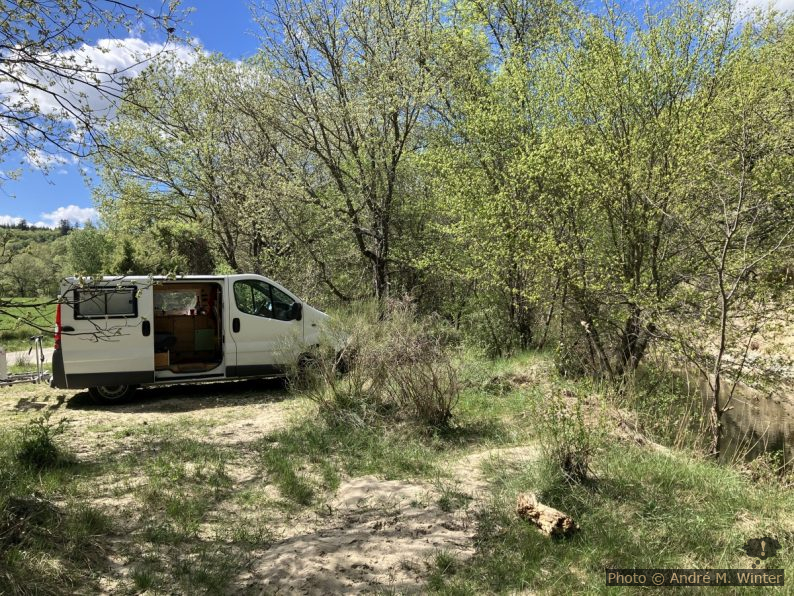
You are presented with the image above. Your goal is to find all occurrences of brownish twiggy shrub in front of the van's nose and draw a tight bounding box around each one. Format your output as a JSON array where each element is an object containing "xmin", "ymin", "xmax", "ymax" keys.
[{"xmin": 293, "ymin": 301, "xmax": 460, "ymax": 427}]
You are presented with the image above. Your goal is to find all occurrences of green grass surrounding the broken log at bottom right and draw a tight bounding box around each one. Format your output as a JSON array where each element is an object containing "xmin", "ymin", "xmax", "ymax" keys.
[{"xmin": 429, "ymin": 445, "xmax": 794, "ymax": 594}]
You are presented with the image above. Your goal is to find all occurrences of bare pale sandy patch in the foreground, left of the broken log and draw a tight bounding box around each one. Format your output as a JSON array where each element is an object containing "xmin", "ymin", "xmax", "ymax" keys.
[{"xmin": 237, "ymin": 446, "xmax": 539, "ymax": 595}]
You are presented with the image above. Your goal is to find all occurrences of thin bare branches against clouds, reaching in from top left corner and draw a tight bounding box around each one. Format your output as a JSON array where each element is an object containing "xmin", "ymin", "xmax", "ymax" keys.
[{"xmin": 0, "ymin": 0, "xmax": 179, "ymax": 163}]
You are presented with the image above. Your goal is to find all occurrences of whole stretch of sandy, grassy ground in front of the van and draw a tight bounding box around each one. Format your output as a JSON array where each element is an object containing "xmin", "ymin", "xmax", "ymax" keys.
[{"xmin": 0, "ymin": 354, "xmax": 794, "ymax": 594}]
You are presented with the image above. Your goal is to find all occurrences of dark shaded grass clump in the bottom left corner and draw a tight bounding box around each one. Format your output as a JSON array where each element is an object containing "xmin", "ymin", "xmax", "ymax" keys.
[{"xmin": 0, "ymin": 417, "xmax": 107, "ymax": 594}]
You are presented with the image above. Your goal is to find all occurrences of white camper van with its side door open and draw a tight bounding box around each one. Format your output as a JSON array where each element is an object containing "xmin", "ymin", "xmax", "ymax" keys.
[{"xmin": 52, "ymin": 275, "xmax": 328, "ymax": 403}]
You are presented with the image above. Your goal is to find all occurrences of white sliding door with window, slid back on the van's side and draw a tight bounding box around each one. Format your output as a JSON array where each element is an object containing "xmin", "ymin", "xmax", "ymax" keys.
[{"xmin": 61, "ymin": 279, "xmax": 154, "ymax": 389}]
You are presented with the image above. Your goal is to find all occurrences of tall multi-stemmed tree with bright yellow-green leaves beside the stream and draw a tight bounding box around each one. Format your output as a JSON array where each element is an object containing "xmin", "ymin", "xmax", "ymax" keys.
[{"xmin": 524, "ymin": 1, "xmax": 733, "ymax": 379}]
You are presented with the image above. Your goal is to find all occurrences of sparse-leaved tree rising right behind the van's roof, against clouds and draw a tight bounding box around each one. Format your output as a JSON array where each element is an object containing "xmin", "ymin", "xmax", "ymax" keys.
[{"xmin": 95, "ymin": 56, "xmax": 284, "ymax": 272}]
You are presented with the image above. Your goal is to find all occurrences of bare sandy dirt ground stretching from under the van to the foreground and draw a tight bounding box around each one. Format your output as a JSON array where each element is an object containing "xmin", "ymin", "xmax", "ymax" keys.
[{"xmin": 0, "ymin": 381, "xmax": 537, "ymax": 594}]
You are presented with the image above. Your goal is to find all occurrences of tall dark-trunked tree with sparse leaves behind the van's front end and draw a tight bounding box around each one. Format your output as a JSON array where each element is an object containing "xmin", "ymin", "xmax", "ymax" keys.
[{"xmin": 248, "ymin": 0, "xmax": 441, "ymax": 300}]
